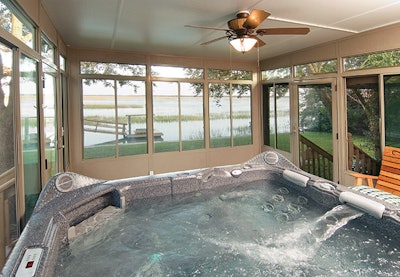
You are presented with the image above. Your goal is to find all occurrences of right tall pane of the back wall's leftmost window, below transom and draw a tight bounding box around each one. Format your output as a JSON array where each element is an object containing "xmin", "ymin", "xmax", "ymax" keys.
[{"xmin": 117, "ymin": 81, "xmax": 147, "ymax": 156}]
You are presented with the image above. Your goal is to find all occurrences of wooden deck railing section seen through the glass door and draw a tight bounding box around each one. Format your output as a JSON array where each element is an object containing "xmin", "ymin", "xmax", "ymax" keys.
[{"xmin": 300, "ymin": 135, "xmax": 333, "ymax": 180}]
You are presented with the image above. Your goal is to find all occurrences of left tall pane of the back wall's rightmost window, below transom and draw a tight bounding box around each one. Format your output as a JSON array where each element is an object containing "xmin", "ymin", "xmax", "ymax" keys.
[{"xmin": 209, "ymin": 84, "xmax": 231, "ymax": 147}]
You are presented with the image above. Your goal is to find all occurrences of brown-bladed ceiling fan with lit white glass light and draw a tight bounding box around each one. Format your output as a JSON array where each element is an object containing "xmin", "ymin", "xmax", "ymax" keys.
[{"xmin": 185, "ymin": 10, "xmax": 310, "ymax": 53}]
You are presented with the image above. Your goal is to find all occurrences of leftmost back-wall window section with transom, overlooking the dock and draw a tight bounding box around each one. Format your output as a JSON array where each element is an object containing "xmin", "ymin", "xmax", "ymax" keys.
[{"xmin": 80, "ymin": 62, "xmax": 148, "ymax": 159}]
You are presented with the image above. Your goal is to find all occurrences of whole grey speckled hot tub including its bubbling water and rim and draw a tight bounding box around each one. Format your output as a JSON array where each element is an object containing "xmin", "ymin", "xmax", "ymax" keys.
[{"xmin": 3, "ymin": 152, "xmax": 400, "ymax": 276}]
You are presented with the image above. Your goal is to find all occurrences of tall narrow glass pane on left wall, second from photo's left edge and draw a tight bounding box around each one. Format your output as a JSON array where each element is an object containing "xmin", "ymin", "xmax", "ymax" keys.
[{"xmin": 20, "ymin": 55, "xmax": 41, "ymax": 219}]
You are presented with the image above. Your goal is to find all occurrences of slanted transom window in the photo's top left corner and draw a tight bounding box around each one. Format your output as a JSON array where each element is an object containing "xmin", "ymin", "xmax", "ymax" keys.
[{"xmin": 0, "ymin": 0, "xmax": 36, "ymax": 49}]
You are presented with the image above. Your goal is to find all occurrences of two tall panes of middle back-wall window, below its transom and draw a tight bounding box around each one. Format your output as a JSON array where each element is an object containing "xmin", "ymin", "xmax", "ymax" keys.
[{"xmin": 153, "ymin": 81, "xmax": 204, "ymax": 152}]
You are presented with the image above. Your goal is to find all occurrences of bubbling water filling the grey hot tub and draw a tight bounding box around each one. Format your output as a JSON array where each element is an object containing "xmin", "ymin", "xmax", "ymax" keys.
[{"xmin": 56, "ymin": 182, "xmax": 400, "ymax": 276}]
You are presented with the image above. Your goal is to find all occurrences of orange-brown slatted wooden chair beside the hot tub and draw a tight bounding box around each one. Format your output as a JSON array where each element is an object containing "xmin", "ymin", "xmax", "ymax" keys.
[{"xmin": 350, "ymin": 146, "xmax": 400, "ymax": 196}]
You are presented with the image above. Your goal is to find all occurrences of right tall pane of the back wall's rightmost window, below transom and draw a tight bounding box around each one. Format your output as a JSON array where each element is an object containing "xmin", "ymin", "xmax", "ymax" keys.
[{"xmin": 232, "ymin": 85, "xmax": 253, "ymax": 146}]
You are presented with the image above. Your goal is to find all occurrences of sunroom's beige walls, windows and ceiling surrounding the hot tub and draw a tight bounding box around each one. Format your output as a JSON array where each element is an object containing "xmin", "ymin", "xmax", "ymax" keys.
[{"xmin": 0, "ymin": 0, "xmax": 400, "ymax": 266}]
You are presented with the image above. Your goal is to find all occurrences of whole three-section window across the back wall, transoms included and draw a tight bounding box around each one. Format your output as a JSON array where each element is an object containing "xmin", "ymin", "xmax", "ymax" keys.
[{"xmin": 80, "ymin": 62, "xmax": 253, "ymax": 159}]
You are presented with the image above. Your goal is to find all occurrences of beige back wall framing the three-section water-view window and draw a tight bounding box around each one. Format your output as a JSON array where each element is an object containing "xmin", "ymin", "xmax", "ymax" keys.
[{"xmin": 67, "ymin": 48, "xmax": 261, "ymax": 179}]
